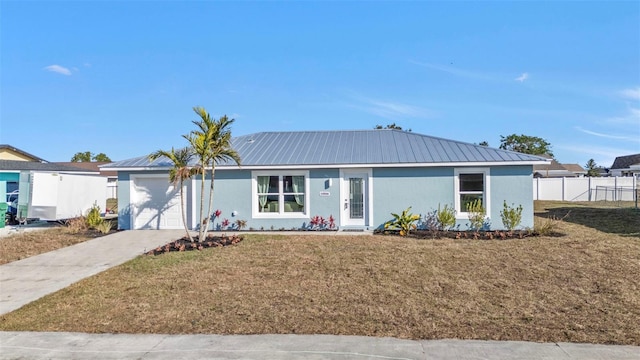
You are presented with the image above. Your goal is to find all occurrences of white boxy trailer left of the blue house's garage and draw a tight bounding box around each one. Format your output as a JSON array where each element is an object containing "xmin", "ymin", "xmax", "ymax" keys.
[{"xmin": 18, "ymin": 171, "xmax": 107, "ymax": 221}]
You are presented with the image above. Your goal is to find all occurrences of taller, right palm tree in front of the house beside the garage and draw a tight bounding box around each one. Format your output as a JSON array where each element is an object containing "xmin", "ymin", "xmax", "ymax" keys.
[{"xmin": 183, "ymin": 107, "xmax": 240, "ymax": 242}]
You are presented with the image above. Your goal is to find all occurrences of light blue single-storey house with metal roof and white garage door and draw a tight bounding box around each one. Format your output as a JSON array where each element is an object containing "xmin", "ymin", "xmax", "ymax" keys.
[{"xmin": 102, "ymin": 129, "xmax": 549, "ymax": 229}]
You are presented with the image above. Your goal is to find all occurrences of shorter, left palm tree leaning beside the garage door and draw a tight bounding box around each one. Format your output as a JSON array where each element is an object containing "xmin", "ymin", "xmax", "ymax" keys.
[{"xmin": 149, "ymin": 147, "xmax": 199, "ymax": 242}]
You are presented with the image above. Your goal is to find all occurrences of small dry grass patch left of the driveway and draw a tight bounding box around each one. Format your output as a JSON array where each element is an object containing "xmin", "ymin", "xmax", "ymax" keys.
[{"xmin": 0, "ymin": 227, "xmax": 95, "ymax": 265}]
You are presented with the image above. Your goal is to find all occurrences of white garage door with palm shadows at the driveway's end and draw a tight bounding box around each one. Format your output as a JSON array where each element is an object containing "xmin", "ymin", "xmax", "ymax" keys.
[{"xmin": 131, "ymin": 176, "xmax": 186, "ymax": 229}]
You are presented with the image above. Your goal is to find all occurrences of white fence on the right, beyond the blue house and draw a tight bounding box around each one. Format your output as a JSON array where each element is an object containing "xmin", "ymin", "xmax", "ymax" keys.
[{"xmin": 533, "ymin": 177, "xmax": 638, "ymax": 201}]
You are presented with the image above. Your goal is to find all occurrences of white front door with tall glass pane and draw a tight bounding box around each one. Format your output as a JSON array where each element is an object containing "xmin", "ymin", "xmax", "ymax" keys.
[{"xmin": 340, "ymin": 170, "xmax": 370, "ymax": 226}]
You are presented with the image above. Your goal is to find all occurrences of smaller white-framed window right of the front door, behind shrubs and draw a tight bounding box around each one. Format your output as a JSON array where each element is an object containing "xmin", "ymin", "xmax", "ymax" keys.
[{"xmin": 455, "ymin": 168, "xmax": 490, "ymax": 218}]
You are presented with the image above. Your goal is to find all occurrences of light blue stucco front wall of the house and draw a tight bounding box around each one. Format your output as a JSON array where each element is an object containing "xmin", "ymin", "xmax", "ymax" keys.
[{"xmin": 118, "ymin": 166, "xmax": 533, "ymax": 230}]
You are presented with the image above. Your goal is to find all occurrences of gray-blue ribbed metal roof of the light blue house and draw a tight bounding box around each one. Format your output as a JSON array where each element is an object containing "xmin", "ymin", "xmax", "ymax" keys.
[{"xmin": 103, "ymin": 129, "xmax": 547, "ymax": 168}]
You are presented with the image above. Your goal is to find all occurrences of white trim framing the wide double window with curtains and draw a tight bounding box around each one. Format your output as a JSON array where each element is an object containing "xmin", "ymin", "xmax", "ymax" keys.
[{"xmin": 251, "ymin": 170, "xmax": 311, "ymax": 219}]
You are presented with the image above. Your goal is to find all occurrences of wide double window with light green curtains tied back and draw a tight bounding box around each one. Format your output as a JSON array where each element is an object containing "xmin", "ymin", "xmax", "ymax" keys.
[{"xmin": 253, "ymin": 172, "xmax": 308, "ymax": 217}]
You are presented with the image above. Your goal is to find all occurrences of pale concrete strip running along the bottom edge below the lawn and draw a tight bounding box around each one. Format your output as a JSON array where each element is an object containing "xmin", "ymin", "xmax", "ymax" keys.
[{"xmin": 0, "ymin": 332, "xmax": 640, "ymax": 360}]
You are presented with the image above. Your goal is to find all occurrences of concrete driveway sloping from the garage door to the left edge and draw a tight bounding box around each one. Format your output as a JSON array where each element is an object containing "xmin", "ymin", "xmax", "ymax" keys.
[{"xmin": 0, "ymin": 230, "xmax": 184, "ymax": 315}]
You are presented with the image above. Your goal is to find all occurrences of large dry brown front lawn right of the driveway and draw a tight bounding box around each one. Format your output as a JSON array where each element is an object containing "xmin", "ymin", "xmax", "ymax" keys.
[{"xmin": 0, "ymin": 218, "xmax": 640, "ymax": 345}]
